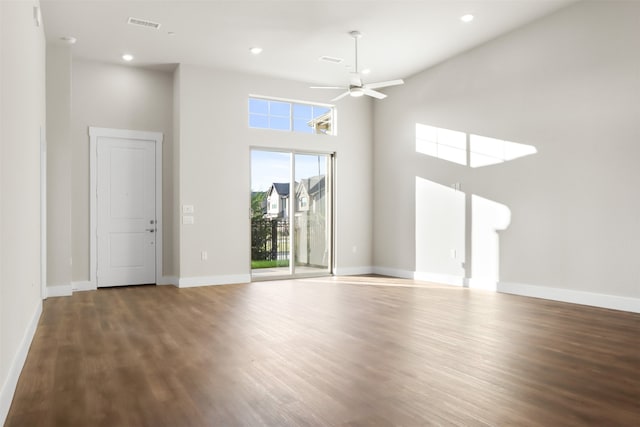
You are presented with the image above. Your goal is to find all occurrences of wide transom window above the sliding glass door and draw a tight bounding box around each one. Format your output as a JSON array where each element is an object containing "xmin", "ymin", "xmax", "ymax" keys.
[{"xmin": 249, "ymin": 97, "xmax": 335, "ymax": 135}]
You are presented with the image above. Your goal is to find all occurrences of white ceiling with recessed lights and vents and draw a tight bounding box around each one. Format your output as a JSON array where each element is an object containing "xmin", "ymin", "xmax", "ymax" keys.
[{"xmin": 41, "ymin": 0, "xmax": 576, "ymax": 85}]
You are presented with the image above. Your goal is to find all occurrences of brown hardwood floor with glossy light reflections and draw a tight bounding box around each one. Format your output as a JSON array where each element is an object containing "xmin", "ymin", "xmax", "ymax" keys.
[{"xmin": 6, "ymin": 277, "xmax": 640, "ymax": 427}]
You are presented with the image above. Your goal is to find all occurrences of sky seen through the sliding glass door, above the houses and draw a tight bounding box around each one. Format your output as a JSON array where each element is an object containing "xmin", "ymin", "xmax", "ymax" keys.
[{"xmin": 251, "ymin": 150, "xmax": 329, "ymax": 191}]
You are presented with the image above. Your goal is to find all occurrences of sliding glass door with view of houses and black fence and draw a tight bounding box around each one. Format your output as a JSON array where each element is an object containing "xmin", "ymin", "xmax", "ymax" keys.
[{"xmin": 251, "ymin": 150, "xmax": 333, "ymax": 280}]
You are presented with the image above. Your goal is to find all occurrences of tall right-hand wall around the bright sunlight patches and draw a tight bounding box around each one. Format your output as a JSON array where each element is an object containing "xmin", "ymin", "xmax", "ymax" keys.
[{"xmin": 374, "ymin": 1, "xmax": 640, "ymax": 310}]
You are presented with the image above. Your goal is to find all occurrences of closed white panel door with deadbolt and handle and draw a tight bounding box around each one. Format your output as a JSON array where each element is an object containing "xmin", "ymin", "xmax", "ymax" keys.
[{"xmin": 96, "ymin": 137, "xmax": 157, "ymax": 287}]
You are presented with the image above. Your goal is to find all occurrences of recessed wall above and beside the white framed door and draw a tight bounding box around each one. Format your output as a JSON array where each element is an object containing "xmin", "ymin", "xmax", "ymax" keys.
[{"xmin": 70, "ymin": 59, "xmax": 175, "ymax": 282}]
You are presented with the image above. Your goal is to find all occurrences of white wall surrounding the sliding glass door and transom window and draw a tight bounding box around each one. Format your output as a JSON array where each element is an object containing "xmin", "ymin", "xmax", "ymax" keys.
[{"xmin": 176, "ymin": 65, "xmax": 372, "ymax": 284}]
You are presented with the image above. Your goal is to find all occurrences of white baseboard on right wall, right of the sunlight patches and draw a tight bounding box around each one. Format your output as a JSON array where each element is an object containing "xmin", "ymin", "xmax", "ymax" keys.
[{"xmin": 497, "ymin": 282, "xmax": 640, "ymax": 313}]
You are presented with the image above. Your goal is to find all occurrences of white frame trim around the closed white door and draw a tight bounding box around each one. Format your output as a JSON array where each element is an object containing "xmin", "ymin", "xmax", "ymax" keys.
[{"xmin": 89, "ymin": 127, "xmax": 164, "ymax": 289}]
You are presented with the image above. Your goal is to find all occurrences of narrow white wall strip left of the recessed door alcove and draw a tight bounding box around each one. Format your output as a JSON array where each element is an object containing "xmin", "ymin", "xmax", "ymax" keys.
[{"xmin": 46, "ymin": 44, "xmax": 72, "ymax": 294}]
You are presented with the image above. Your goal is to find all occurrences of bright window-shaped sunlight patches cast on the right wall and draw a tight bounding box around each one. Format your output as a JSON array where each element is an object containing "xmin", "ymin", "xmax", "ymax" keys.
[{"xmin": 415, "ymin": 123, "xmax": 537, "ymax": 290}]
